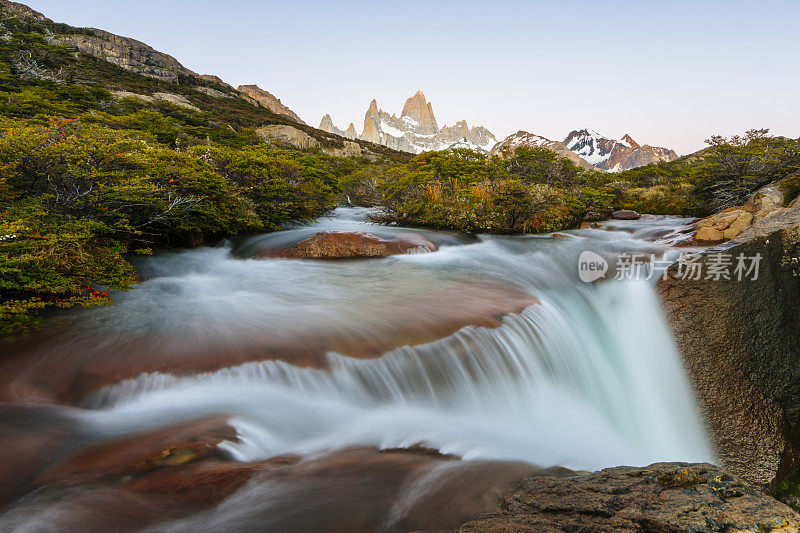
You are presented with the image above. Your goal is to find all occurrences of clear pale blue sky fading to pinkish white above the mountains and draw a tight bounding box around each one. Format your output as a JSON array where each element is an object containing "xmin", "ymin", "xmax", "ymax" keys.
[{"xmin": 22, "ymin": 0, "xmax": 800, "ymax": 154}]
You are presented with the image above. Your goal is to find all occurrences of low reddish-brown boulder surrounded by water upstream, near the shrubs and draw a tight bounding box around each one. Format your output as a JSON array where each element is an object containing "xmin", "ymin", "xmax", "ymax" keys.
[{"xmin": 256, "ymin": 231, "xmax": 437, "ymax": 259}]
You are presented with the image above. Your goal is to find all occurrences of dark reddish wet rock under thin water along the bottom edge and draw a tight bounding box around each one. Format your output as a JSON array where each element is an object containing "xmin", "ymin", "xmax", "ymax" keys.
[{"xmin": 0, "ymin": 448, "xmax": 544, "ymax": 533}]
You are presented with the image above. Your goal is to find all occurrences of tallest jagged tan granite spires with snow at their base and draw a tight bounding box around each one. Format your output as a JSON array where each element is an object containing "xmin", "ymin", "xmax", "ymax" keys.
[{"xmin": 320, "ymin": 91, "xmax": 497, "ymax": 154}]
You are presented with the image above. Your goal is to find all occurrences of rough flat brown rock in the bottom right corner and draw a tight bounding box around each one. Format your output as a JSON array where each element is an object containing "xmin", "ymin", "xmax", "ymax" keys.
[{"xmin": 458, "ymin": 463, "xmax": 800, "ymax": 533}]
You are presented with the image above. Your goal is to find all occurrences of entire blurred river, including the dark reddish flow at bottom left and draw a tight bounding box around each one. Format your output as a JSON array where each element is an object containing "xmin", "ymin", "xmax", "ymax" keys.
[{"xmin": 0, "ymin": 209, "xmax": 712, "ymax": 533}]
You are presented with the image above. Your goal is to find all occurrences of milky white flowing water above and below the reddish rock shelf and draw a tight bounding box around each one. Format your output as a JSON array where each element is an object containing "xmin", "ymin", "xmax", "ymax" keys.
[{"xmin": 69, "ymin": 211, "xmax": 712, "ymax": 469}]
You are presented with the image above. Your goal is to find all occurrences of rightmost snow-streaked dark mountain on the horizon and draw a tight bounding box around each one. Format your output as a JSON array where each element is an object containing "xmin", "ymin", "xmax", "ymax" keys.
[{"xmin": 564, "ymin": 129, "xmax": 678, "ymax": 172}]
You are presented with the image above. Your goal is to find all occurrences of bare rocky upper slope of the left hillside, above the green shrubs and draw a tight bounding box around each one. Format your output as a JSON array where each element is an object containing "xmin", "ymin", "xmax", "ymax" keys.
[{"xmin": 0, "ymin": 0, "xmax": 408, "ymax": 161}]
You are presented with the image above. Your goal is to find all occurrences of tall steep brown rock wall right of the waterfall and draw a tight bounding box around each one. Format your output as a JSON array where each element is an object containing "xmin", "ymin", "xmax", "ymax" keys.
[{"xmin": 657, "ymin": 207, "xmax": 800, "ymax": 488}]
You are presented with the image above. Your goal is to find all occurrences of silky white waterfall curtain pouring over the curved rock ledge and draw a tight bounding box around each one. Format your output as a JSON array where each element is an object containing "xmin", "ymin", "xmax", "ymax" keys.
[{"xmin": 78, "ymin": 241, "xmax": 712, "ymax": 469}]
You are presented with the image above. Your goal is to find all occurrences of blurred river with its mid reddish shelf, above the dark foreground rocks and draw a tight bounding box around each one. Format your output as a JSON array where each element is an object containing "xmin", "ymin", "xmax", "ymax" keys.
[{"xmin": 0, "ymin": 208, "xmax": 713, "ymax": 530}]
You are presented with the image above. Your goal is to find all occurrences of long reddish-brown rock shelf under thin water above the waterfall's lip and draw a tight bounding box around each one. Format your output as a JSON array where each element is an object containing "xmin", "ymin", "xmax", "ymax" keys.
[{"xmin": 0, "ymin": 279, "xmax": 536, "ymax": 403}]
